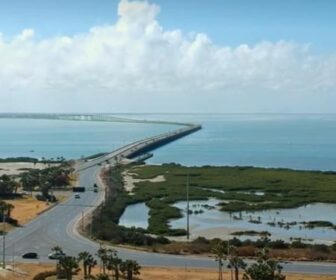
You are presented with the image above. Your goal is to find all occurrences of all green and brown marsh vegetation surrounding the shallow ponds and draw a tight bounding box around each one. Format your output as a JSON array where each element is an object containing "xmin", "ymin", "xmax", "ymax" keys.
[{"xmin": 92, "ymin": 164, "xmax": 336, "ymax": 260}]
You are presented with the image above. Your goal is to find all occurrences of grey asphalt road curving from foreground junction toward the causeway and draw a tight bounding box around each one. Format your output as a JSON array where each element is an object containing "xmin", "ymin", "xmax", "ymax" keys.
[{"xmin": 0, "ymin": 139, "xmax": 336, "ymax": 275}]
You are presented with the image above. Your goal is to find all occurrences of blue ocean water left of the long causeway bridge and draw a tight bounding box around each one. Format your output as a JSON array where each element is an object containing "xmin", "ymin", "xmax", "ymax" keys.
[{"xmin": 0, "ymin": 119, "xmax": 177, "ymax": 159}]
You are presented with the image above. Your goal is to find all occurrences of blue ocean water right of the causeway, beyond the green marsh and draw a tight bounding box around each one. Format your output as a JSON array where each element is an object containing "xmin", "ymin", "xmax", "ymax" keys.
[{"xmin": 142, "ymin": 115, "xmax": 336, "ymax": 170}]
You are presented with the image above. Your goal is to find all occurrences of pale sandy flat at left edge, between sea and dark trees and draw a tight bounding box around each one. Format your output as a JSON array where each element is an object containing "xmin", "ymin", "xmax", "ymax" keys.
[{"xmin": 0, "ymin": 162, "xmax": 58, "ymax": 176}]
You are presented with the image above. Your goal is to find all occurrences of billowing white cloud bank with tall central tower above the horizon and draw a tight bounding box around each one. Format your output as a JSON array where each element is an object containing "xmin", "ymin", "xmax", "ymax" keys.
[{"xmin": 0, "ymin": 0, "xmax": 336, "ymax": 112}]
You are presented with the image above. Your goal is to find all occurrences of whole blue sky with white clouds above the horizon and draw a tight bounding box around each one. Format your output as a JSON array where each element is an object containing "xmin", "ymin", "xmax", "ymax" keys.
[{"xmin": 0, "ymin": 0, "xmax": 336, "ymax": 113}]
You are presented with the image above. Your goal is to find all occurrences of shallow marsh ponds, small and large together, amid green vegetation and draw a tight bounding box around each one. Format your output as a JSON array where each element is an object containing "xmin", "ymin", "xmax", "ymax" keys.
[{"xmin": 119, "ymin": 198, "xmax": 336, "ymax": 244}]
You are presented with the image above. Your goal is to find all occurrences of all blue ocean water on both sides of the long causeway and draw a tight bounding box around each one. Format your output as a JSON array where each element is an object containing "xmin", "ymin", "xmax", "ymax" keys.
[{"xmin": 0, "ymin": 114, "xmax": 336, "ymax": 170}]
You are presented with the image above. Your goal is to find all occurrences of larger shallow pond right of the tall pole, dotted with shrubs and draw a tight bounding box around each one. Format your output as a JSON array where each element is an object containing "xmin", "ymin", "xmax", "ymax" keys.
[{"xmin": 170, "ymin": 199, "xmax": 336, "ymax": 243}]
